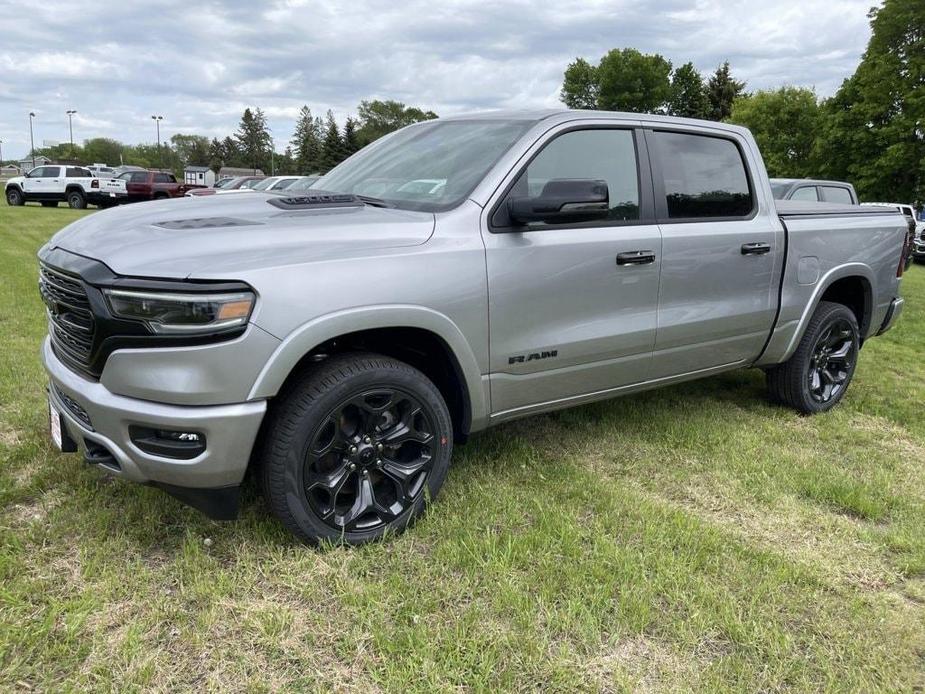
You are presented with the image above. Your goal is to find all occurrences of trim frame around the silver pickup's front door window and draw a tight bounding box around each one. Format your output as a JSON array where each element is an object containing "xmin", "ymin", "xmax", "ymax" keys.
[{"xmin": 487, "ymin": 123, "xmax": 656, "ymax": 234}]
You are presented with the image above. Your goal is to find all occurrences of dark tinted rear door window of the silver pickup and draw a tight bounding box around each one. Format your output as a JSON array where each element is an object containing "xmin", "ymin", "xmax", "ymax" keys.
[{"xmin": 652, "ymin": 131, "xmax": 755, "ymax": 219}]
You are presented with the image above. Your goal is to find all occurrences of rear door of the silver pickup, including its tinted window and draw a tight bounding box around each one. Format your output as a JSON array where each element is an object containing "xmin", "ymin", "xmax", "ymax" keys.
[{"xmin": 646, "ymin": 129, "xmax": 783, "ymax": 378}]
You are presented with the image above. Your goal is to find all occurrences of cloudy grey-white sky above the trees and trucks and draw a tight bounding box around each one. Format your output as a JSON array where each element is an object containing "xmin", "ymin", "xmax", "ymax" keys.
[{"xmin": 0, "ymin": 0, "xmax": 874, "ymax": 163}]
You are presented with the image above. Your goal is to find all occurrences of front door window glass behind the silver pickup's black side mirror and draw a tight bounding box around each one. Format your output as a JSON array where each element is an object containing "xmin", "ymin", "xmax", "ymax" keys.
[{"xmin": 496, "ymin": 129, "xmax": 639, "ymax": 228}]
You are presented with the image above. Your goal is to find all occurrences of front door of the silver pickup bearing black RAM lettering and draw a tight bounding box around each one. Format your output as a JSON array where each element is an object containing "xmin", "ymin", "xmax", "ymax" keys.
[{"xmin": 483, "ymin": 126, "xmax": 661, "ymax": 415}]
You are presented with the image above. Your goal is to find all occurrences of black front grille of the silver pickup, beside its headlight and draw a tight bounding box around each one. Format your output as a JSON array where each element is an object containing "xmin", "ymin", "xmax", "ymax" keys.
[{"xmin": 39, "ymin": 265, "xmax": 95, "ymax": 370}]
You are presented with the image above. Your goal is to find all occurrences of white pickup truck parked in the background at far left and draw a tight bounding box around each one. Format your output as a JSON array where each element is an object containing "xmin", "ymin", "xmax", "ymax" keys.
[{"xmin": 6, "ymin": 165, "xmax": 127, "ymax": 210}]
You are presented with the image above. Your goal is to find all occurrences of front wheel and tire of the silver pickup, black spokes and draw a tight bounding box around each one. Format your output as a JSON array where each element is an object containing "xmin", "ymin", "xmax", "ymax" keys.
[{"xmin": 260, "ymin": 353, "xmax": 453, "ymax": 545}]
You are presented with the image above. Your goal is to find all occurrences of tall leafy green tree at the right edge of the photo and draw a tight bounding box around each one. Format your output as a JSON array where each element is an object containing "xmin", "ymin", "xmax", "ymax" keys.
[{"xmin": 819, "ymin": 0, "xmax": 925, "ymax": 202}]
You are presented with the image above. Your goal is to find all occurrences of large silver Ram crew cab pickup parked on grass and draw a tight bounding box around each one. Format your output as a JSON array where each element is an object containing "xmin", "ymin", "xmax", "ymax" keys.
[{"xmin": 39, "ymin": 111, "xmax": 906, "ymax": 543}]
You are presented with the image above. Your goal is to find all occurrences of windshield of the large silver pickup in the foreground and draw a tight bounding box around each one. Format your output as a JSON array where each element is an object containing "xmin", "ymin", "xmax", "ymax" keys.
[{"xmin": 312, "ymin": 120, "xmax": 533, "ymax": 212}]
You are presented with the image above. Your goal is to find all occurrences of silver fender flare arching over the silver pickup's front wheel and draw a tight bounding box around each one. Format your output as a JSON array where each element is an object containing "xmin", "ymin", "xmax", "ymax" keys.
[{"xmin": 248, "ymin": 304, "xmax": 489, "ymax": 431}]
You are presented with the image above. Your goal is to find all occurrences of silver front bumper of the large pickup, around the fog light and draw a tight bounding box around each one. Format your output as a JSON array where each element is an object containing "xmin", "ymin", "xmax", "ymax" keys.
[{"xmin": 42, "ymin": 337, "xmax": 267, "ymax": 490}]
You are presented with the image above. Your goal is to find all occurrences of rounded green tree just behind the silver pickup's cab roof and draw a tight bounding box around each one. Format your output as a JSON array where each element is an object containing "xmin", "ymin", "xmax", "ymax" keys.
[{"xmin": 729, "ymin": 87, "xmax": 821, "ymax": 178}]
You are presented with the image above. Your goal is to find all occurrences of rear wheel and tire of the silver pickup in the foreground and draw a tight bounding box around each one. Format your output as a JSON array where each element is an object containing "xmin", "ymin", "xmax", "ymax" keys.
[{"xmin": 767, "ymin": 301, "xmax": 860, "ymax": 414}]
